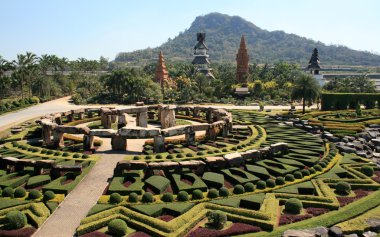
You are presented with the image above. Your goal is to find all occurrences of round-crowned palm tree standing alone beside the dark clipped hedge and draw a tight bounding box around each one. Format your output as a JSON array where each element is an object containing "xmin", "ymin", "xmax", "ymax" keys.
[{"xmin": 292, "ymin": 72, "xmax": 321, "ymax": 113}]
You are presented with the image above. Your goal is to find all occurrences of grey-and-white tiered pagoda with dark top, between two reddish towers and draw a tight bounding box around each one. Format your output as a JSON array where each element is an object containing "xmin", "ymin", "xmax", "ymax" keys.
[{"xmin": 192, "ymin": 33, "xmax": 215, "ymax": 79}]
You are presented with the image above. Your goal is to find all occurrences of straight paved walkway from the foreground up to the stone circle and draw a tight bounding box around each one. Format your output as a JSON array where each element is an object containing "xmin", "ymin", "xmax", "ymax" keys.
[{"xmin": 33, "ymin": 139, "xmax": 125, "ymax": 237}]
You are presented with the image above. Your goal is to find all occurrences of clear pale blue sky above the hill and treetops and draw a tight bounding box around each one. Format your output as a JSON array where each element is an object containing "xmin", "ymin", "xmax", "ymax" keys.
[{"xmin": 0, "ymin": 0, "xmax": 380, "ymax": 60}]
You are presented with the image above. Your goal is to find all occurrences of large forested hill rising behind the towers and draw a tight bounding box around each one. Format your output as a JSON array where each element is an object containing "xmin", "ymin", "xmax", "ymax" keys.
[{"xmin": 115, "ymin": 13, "xmax": 380, "ymax": 66}]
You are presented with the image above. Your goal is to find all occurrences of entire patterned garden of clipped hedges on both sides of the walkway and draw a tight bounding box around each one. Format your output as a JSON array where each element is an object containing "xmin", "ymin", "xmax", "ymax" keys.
[{"xmin": 0, "ymin": 104, "xmax": 380, "ymax": 237}]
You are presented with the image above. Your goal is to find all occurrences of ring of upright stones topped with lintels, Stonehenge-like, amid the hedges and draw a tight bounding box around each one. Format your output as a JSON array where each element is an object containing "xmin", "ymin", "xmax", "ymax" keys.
[{"xmin": 37, "ymin": 105, "xmax": 232, "ymax": 152}]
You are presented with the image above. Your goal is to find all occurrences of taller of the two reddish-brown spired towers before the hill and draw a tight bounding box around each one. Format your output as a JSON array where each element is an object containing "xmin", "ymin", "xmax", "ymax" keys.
[{"xmin": 236, "ymin": 35, "xmax": 249, "ymax": 83}]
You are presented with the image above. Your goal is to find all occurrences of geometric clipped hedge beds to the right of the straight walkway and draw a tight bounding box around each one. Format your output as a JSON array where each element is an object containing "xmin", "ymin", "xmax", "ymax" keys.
[{"xmin": 77, "ymin": 110, "xmax": 380, "ymax": 236}]
